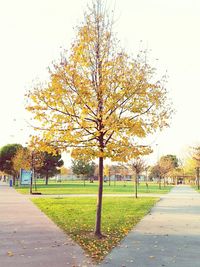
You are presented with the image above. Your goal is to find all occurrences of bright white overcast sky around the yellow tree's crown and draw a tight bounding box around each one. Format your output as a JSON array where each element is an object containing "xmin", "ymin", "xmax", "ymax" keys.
[{"xmin": 0, "ymin": 0, "xmax": 200, "ymax": 164}]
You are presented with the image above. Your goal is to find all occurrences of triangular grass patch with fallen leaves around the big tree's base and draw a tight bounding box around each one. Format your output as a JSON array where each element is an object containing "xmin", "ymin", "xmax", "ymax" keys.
[{"xmin": 32, "ymin": 197, "xmax": 158, "ymax": 262}]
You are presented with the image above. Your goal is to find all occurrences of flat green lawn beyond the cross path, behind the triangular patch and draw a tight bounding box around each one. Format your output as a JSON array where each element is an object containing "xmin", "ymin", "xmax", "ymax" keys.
[{"xmin": 16, "ymin": 181, "xmax": 173, "ymax": 195}]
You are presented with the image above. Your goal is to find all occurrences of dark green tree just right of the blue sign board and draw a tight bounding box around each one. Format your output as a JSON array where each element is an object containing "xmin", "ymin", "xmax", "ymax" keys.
[{"xmin": 36, "ymin": 152, "xmax": 64, "ymax": 185}]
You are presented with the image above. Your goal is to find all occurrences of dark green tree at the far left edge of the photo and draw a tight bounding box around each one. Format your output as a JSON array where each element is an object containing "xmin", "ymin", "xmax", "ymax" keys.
[{"xmin": 0, "ymin": 144, "xmax": 22, "ymax": 185}]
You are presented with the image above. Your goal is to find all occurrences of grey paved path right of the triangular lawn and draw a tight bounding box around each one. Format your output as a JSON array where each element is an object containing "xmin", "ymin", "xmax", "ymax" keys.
[{"xmin": 100, "ymin": 186, "xmax": 200, "ymax": 267}]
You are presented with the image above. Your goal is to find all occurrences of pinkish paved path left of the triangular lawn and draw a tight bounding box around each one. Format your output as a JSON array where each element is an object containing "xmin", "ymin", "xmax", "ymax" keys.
[{"xmin": 0, "ymin": 182, "xmax": 92, "ymax": 267}]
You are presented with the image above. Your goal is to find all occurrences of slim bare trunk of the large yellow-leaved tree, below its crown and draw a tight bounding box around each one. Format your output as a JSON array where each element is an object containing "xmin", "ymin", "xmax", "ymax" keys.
[{"xmin": 95, "ymin": 157, "xmax": 103, "ymax": 238}]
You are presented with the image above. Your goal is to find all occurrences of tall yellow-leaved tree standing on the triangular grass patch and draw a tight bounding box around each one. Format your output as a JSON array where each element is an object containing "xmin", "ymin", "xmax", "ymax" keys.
[{"xmin": 27, "ymin": 0, "xmax": 171, "ymax": 237}]
